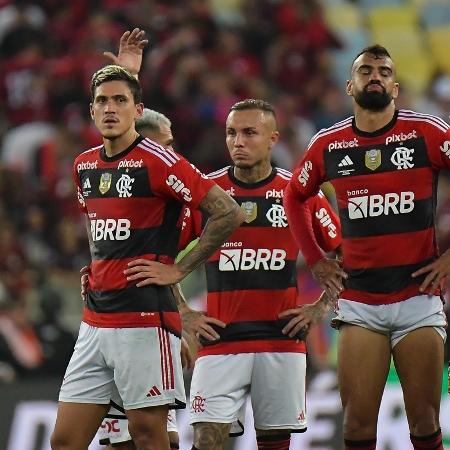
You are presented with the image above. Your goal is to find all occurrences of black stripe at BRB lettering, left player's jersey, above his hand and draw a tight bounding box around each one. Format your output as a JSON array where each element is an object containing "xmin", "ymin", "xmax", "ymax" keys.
[{"xmin": 89, "ymin": 225, "xmax": 180, "ymax": 260}]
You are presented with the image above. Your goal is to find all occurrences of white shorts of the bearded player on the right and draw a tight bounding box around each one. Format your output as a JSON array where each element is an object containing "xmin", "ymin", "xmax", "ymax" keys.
[{"xmin": 331, "ymin": 295, "xmax": 447, "ymax": 348}]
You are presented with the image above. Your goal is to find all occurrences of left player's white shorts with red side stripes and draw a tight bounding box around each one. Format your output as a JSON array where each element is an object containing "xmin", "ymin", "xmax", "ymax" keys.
[{"xmin": 59, "ymin": 322, "xmax": 185, "ymax": 410}]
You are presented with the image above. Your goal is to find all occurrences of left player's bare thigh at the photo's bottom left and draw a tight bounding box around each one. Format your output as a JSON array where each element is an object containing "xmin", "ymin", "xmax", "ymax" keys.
[{"xmin": 52, "ymin": 402, "xmax": 109, "ymax": 449}]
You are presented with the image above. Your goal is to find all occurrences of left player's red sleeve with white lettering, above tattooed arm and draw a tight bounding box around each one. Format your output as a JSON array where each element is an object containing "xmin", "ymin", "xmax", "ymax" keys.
[{"xmin": 149, "ymin": 150, "xmax": 215, "ymax": 210}]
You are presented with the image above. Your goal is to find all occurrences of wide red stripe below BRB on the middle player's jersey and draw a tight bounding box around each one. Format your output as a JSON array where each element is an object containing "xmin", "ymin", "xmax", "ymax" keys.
[{"xmin": 207, "ymin": 287, "xmax": 297, "ymax": 323}]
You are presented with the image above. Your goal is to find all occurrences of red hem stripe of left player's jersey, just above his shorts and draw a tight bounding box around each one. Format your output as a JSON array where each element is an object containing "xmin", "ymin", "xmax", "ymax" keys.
[{"xmin": 82, "ymin": 308, "xmax": 182, "ymax": 334}]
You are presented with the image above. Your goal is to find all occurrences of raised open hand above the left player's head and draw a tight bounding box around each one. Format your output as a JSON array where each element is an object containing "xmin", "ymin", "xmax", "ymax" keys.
[{"xmin": 103, "ymin": 28, "xmax": 148, "ymax": 77}]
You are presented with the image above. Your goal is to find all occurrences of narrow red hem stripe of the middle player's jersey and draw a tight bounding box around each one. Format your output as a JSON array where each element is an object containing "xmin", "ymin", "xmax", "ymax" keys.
[{"xmin": 198, "ymin": 340, "xmax": 306, "ymax": 356}]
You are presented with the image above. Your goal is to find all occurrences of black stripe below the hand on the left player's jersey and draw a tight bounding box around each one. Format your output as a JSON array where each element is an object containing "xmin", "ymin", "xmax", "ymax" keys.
[{"xmin": 86, "ymin": 285, "xmax": 178, "ymax": 314}]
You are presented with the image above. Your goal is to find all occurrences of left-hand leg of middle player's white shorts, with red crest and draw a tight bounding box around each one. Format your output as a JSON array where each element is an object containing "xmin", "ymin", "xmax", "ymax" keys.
[{"xmin": 189, "ymin": 353, "xmax": 254, "ymax": 424}]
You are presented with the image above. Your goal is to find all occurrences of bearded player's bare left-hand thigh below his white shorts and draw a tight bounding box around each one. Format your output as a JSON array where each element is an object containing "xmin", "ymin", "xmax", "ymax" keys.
[{"xmin": 338, "ymin": 324, "xmax": 391, "ymax": 419}]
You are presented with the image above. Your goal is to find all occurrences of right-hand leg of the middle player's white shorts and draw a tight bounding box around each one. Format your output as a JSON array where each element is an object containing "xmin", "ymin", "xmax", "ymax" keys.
[{"xmin": 250, "ymin": 352, "xmax": 307, "ymax": 432}]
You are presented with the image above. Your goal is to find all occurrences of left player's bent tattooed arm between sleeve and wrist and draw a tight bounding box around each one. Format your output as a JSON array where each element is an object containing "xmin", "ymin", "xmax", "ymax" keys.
[{"xmin": 178, "ymin": 186, "xmax": 244, "ymax": 273}]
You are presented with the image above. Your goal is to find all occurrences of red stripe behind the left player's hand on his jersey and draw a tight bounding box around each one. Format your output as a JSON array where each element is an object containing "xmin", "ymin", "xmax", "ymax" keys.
[{"xmin": 89, "ymin": 253, "xmax": 174, "ymax": 291}]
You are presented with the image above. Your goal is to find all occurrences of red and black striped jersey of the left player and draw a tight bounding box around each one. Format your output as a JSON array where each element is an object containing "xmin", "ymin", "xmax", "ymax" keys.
[{"xmin": 73, "ymin": 137, "xmax": 214, "ymax": 333}]
